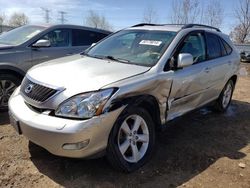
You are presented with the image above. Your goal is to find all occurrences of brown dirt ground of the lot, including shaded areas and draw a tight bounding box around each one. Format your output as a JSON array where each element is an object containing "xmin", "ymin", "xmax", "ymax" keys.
[{"xmin": 0, "ymin": 63, "xmax": 250, "ymax": 188}]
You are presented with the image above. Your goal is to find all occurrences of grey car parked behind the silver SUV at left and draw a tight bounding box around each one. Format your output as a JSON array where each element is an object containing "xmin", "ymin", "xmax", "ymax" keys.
[{"xmin": 0, "ymin": 25, "xmax": 111, "ymax": 110}]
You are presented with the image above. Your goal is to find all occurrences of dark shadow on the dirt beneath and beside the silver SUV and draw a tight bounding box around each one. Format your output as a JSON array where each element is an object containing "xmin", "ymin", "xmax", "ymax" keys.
[{"xmin": 29, "ymin": 100, "xmax": 250, "ymax": 187}]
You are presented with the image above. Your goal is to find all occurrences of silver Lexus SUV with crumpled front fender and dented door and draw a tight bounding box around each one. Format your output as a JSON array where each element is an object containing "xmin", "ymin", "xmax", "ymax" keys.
[{"xmin": 9, "ymin": 24, "xmax": 240, "ymax": 172}]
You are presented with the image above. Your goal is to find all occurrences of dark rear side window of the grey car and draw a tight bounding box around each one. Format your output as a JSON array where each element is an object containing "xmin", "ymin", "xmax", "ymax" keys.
[{"xmin": 72, "ymin": 29, "xmax": 107, "ymax": 46}]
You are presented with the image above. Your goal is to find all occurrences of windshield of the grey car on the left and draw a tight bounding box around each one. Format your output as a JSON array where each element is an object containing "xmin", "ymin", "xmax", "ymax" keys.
[{"xmin": 0, "ymin": 25, "xmax": 46, "ymax": 46}]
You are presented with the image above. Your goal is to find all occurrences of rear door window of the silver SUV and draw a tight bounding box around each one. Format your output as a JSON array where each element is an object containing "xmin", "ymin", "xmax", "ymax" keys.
[{"xmin": 207, "ymin": 33, "xmax": 221, "ymax": 59}]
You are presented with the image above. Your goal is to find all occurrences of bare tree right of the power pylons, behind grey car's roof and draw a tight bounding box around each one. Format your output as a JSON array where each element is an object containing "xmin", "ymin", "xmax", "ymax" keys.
[{"xmin": 85, "ymin": 10, "xmax": 113, "ymax": 30}]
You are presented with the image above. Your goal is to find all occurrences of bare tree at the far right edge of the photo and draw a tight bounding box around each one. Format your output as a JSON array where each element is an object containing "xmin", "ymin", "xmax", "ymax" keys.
[{"xmin": 230, "ymin": 0, "xmax": 250, "ymax": 43}]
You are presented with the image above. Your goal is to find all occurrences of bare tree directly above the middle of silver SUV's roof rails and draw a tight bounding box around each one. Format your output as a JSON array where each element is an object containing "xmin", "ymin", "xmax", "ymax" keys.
[{"xmin": 171, "ymin": 0, "xmax": 201, "ymax": 24}]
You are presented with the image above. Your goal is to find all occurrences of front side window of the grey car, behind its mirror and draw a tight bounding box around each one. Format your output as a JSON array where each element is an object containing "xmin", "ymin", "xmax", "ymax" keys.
[{"xmin": 41, "ymin": 29, "xmax": 69, "ymax": 47}]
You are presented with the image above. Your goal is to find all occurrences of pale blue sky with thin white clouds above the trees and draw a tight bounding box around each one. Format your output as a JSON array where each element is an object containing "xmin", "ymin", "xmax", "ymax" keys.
[{"xmin": 0, "ymin": 0, "xmax": 239, "ymax": 33}]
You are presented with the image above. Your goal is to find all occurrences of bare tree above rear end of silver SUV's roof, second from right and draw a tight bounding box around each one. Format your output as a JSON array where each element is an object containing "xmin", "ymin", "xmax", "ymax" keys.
[{"xmin": 203, "ymin": 0, "xmax": 224, "ymax": 27}]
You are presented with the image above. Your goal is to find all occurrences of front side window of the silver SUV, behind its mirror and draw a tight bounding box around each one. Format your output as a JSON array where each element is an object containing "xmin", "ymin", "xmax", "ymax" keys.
[{"xmin": 179, "ymin": 33, "xmax": 206, "ymax": 63}]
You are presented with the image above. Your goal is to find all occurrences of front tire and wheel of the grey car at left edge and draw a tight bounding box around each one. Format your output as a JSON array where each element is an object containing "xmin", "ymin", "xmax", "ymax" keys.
[{"xmin": 0, "ymin": 72, "xmax": 22, "ymax": 112}]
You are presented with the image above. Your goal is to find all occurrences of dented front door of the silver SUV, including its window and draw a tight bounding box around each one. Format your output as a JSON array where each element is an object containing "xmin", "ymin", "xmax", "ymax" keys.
[{"xmin": 167, "ymin": 31, "xmax": 211, "ymax": 120}]
